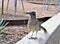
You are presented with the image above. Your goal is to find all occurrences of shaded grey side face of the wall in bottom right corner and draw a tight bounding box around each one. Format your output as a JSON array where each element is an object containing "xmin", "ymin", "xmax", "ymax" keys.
[{"xmin": 46, "ymin": 25, "xmax": 60, "ymax": 44}]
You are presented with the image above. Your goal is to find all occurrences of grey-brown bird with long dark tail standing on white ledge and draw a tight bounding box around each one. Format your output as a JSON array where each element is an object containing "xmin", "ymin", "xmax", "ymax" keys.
[{"xmin": 26, "ymin": 11, "xmax": 47, "ymax": 39}]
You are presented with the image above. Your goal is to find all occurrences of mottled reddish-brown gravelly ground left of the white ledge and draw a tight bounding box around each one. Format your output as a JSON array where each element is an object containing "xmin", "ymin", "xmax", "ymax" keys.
[{"xmin": 2, "ymin": 26, "xmax": 30, "ymax": 44}]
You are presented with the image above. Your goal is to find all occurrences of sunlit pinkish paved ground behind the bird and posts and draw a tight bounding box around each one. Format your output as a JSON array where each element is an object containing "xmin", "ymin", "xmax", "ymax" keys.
[{"xmin": 0, "ymin": 0, "xmax": 56, "ymax": 18}]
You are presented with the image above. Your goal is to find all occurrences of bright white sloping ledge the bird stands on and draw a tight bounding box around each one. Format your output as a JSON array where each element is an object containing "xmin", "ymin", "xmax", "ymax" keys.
[{"xmin": 16, "ymin": 13, "xmax": 60, "ymax": 44}]
